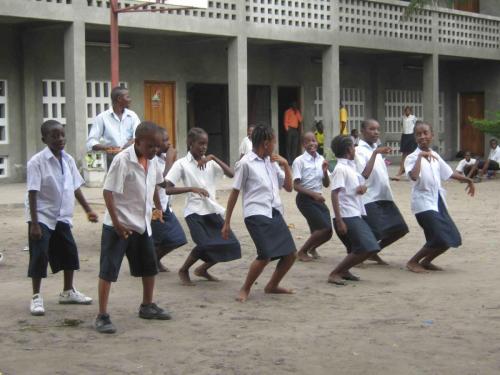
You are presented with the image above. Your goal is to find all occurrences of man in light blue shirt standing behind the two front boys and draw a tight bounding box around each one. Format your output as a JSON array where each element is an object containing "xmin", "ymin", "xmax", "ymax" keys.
[{"xmin": 87, "ymin": 87, "xmax": 141, "ymax": 168}]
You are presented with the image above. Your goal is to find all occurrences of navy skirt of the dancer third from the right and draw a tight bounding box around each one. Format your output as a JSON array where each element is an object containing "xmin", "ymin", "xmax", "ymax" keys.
[{"xmin": 333, "ymin": 216, "xmax": 380, "ymax": 254}]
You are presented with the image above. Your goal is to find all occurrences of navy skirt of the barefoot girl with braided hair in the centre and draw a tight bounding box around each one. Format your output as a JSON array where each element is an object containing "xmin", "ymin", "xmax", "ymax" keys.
[{"xmin": 245, "ymin": 208, "xmax": 296, "ymax": 260}]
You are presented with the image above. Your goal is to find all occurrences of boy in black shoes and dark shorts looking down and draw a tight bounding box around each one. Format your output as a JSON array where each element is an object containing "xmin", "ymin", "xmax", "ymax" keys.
[{"xmin": 95, "ymin": 122, "xmax": 171, "ymax": 333}]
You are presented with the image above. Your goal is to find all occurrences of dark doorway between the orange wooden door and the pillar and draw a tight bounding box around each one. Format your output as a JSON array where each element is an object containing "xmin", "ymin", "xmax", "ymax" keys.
[{"xmin": 187, "ymin": 84, "xmax": 229, "ymax": 163}]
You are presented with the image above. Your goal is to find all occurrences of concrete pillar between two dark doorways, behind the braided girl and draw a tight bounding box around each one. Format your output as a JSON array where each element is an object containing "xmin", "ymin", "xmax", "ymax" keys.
[{"xmin": 227, "ymin": 36, "xmax": 248, "ymax": 164}]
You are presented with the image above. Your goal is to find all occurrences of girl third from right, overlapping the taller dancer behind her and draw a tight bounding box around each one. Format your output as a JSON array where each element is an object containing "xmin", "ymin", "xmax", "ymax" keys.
[{"xmin": 328, "ymin": 135, "xmax": 380, "ymax": 285}]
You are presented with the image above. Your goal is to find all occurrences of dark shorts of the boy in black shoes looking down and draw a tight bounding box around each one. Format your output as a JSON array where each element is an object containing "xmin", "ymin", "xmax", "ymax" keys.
[{"xmin": 99, "ymin": 225, "xmax": 158, "ymax": 282}]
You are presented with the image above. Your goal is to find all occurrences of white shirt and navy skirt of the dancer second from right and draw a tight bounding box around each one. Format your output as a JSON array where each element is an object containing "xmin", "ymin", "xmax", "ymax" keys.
[{"xmin": 355, "ymin": 140, "xmax": 409, "ymax": 241}]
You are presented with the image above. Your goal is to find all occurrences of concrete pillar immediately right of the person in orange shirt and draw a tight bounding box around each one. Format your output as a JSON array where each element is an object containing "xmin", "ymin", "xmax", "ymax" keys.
[{"xmin": 322, "ymin": 44, "xmax": 340, "ymax": 154}]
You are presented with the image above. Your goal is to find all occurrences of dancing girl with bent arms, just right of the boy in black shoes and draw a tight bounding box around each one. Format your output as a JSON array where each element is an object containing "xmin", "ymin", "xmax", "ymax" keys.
[{"xmin": 165, "ymin": 128, "xmax": 241, "ymax": 285}]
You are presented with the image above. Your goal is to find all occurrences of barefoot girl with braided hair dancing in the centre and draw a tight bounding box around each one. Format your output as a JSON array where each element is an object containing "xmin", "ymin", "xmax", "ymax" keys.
[{"xmin": 222, "ymin": 125, "xmax": 296, "ymax": 302}]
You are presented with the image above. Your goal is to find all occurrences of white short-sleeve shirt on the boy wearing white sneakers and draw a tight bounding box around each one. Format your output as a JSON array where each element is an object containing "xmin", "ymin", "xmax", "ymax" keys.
[{"xmin": 25, "ymin": 147, "xmax": 85, "ymax": 230}]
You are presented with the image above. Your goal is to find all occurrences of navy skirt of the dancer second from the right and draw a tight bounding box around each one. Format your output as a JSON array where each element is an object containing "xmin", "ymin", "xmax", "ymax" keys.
[{"xmin": 363, "ymin": 201, "xmax": 409, "ymax": 245}]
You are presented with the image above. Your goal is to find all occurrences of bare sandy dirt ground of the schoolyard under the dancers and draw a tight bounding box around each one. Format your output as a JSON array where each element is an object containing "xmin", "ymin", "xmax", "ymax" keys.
[{"xmin": 0, "ymin": 178, "xmax": 500, "ymax": 374}]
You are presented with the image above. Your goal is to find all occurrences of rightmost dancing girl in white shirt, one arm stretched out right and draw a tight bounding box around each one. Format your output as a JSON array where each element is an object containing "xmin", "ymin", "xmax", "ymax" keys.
[{"xmin": 405, "ymin": 122, "xmax": 474, "ymax": 273}]
